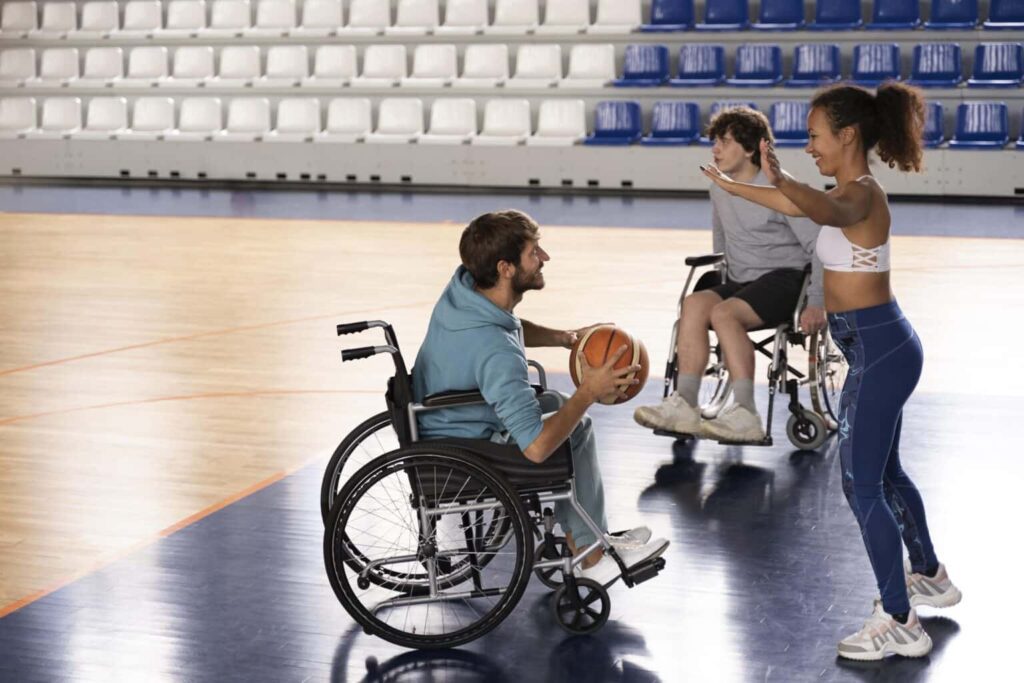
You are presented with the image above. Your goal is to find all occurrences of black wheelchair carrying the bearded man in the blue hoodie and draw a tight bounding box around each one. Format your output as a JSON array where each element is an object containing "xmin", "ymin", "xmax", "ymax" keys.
[{"xmin": 322, "ymin": 321, "xmax": 665, "ymax": 648}]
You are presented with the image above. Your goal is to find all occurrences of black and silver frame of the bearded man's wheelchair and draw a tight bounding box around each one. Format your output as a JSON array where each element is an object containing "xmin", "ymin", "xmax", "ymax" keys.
[{"xmin": 323, "ymin": 321, "xmax": 665, "ymax": 647}]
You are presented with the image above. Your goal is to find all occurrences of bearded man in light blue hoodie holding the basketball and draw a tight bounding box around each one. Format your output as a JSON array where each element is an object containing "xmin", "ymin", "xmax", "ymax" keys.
[{"xmin": 413, "ymin": 211, "xmax": 669, "ymax": 585}]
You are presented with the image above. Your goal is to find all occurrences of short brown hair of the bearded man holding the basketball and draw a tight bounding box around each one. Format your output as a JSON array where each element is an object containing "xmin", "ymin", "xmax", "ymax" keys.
[{"xmin": 459, "ymin": 209, "xmax": 540, "ymax": 289}]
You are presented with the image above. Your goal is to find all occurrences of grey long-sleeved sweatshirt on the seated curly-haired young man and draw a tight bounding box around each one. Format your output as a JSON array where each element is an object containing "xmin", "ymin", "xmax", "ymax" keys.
[{"xmin": 711, "ymin": 171, "xmax": 824, "ymax": 307}]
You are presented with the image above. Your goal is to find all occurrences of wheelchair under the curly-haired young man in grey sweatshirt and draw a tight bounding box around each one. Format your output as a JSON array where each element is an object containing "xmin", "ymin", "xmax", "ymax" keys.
[{"xmin": 654, "ymin": 254, "xmax": 847, "ymax": 451}]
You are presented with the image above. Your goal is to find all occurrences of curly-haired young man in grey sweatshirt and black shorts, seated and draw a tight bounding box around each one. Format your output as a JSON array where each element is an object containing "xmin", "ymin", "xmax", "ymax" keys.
[{"xmin": 633, "ymin": 106, "xmax": 825, "ymax": 441}]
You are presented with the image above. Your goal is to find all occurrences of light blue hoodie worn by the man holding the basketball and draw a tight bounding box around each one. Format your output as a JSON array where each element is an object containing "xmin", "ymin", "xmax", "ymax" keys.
[{"xmin": 413, "ymin": 266, "xmax": 543, "ymax": 449}]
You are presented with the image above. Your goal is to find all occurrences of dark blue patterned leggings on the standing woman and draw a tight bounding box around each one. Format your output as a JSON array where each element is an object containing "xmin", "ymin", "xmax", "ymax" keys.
[{"xmin": 828, "ymin": 301, "xmax": 938, "ymax": 614}]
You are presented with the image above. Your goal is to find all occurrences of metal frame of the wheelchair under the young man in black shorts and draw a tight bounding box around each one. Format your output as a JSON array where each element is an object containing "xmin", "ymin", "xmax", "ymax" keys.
[{"xmin": 653, "ymin": 253, "xmax": 842, "ymax": 451}]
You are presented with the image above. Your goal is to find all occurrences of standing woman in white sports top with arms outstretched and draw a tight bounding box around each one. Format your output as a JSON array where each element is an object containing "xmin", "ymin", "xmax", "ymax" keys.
[{"xmin": 702, "ymin": 83, "xmax": 961, "ymax": 659}]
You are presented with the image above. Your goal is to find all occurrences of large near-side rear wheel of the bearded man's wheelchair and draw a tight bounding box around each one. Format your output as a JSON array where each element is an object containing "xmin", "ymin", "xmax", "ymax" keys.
[{"xmin": 324, "ymin": 445, "xmax": 534, "ymax": 648}]
